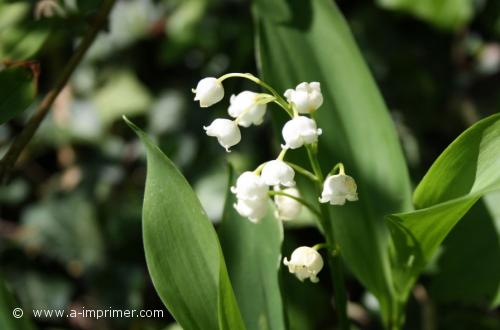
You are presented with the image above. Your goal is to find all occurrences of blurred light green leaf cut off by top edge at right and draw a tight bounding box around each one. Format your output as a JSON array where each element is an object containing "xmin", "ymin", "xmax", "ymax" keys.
[{"xmin": 377, "ymin": 0, "xmax": 477, "ymax": 30}]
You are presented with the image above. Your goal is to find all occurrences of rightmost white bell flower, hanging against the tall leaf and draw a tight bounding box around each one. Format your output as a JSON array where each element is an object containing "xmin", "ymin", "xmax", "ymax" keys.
[{"xmin": 319, "ymin": 173, "xmax": 358, "ymax": 205}]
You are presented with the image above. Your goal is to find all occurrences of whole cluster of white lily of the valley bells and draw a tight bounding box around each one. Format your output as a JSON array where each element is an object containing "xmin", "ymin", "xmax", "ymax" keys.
[{"xmin": 193, "ymin": 73, "xmax": 358, "ymax": 282}]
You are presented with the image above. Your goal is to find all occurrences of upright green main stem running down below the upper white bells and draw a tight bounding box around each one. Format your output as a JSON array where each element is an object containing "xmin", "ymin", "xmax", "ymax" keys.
[{"xmin": 306, "ymin": 144, "xmax": 349, "ymax": 330}]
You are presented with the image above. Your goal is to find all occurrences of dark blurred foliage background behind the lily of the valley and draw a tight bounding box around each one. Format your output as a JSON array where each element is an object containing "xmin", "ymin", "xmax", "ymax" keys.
[{"xmin": 0, "ymin": 0, "xmax": 500, "ymax": 329}]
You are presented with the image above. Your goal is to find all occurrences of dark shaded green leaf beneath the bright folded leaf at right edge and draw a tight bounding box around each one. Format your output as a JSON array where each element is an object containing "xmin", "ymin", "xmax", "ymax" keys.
[{"xmin": 429, "ymin": 192, "xmax": 500, "ymax": 308}]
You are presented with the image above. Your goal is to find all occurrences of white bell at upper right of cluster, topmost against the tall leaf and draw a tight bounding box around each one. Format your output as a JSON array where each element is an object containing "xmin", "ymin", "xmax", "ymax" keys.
[{"xmin": 285, "ymin": 81, "xmax": 323, "ymax": 114}]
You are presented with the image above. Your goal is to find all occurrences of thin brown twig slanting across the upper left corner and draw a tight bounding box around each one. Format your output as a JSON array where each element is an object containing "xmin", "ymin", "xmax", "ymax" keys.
[{"xmin": 0, "ymin": 0, "xmax": 116, "ymax": 182}]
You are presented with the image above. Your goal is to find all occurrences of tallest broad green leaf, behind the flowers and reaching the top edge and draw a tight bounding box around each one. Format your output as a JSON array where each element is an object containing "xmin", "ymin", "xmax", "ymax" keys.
[{"xmin": 255, "ymin": 0, "xmax": 411, "ymax": 319}]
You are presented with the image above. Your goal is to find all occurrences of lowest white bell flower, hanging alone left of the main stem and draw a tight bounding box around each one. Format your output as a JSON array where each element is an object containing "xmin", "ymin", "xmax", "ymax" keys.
[{"xmin": 283, "ymin": 246, "xmax": 324, "ymax": 283}]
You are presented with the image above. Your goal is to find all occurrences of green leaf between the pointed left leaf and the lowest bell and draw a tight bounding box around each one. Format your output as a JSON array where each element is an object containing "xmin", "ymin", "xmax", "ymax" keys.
[{"xmin": 219, "ymin": 168, "xmax": 285, "ymax": 330}]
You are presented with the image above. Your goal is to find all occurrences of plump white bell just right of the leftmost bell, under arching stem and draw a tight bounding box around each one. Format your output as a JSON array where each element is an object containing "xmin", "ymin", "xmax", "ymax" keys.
[{"xmin": 228, "ymin": 91, "xmax": 266, "ymax": 127}]
